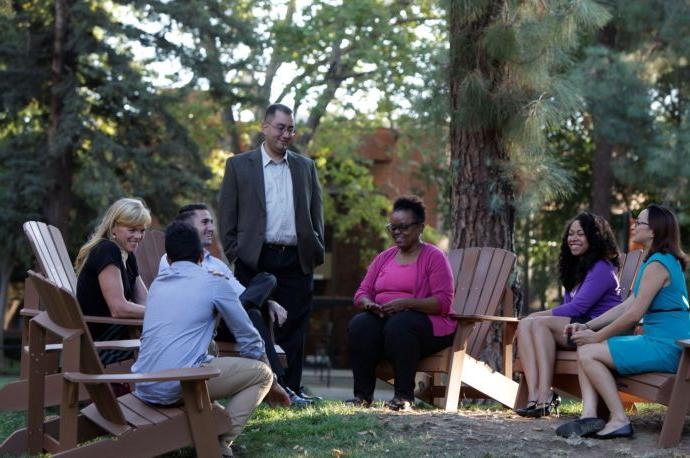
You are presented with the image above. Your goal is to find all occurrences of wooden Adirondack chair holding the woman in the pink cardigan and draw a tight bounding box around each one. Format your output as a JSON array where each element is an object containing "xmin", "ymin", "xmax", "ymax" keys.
[{"xmin": 377, "ymin": 247, "xmax": 518, "ymax": 412}]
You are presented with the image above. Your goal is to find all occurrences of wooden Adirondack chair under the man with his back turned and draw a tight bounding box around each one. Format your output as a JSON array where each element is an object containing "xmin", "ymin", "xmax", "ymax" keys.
[{"xmin": 0, "ymin": 272, "xmax": 230, "ymax": 457}]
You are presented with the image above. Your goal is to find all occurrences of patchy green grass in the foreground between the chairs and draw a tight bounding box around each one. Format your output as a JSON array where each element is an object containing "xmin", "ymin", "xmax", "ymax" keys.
[{"xmin": 0, "ymin": 380, "xmax": 663, "ymax": 458}]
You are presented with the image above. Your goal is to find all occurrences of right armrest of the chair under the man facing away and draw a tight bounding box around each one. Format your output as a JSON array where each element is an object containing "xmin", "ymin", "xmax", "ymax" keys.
[{"xmin": 63, "ymin": 367, "xmax": 220, "ymax": 384}]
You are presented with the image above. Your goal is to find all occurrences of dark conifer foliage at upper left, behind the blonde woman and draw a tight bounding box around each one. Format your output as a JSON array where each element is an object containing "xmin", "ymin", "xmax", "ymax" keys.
[{"xmin": 0, "ymin": 1, "xmax": 208, "ymax": 259}]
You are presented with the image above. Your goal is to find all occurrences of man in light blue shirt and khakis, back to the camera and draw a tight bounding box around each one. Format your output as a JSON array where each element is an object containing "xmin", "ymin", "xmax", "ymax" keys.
[{"xmin": 132, "ymin": 222, "xmax": 289, "ymax": 450}]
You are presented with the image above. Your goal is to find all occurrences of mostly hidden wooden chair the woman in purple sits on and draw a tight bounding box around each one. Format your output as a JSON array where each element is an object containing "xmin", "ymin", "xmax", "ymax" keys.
[{"xmin": 515, "ymin": 250, "xmax": 642, "ymax": 406}]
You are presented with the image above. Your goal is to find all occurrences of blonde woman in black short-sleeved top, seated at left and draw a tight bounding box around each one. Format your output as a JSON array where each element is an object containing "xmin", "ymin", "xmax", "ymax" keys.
[{"xmin": 76, "ymin": 198, "xmax": 151, "ymax": 364}]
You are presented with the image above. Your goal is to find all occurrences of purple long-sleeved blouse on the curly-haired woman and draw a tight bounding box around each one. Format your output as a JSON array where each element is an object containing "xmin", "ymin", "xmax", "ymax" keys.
[{"xmin": 551, "ymin": 260, "xmax": 621, "ymax": 320}]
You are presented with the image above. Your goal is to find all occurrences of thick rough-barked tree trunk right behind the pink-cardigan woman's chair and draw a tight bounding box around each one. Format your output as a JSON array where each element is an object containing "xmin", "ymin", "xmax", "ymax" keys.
[{"xmin": 448, "ymin": 0, "xmax": 522, "ymax": 378}]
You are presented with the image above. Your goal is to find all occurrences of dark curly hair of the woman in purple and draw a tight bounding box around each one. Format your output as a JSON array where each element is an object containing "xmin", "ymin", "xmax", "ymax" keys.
[{"xmin": 558, "ymin": 212, "xmax": 620, "ymax": 291}]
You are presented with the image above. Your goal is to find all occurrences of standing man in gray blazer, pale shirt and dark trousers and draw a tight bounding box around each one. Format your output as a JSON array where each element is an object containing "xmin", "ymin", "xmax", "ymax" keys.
[{"xmin": 219, "ymin": 104, "xmax": 325, "ymax": 405}]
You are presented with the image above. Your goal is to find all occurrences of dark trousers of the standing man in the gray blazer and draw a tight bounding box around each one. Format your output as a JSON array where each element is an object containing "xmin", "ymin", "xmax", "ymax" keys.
[{"xmin": 235, "ymin": 245, "xmax": 314, "ymax": 391}]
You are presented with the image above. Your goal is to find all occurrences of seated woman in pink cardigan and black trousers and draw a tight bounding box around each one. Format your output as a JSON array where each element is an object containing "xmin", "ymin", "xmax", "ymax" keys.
[{"xmin": 348, "ymin": 196, "xmax": 456, "ymax": 410}]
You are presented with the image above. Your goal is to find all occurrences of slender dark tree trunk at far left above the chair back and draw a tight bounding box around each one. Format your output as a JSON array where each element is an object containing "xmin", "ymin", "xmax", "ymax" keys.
[{"xmin": 43, "ymin": 0, "xmax": 73, "ymax": 234}]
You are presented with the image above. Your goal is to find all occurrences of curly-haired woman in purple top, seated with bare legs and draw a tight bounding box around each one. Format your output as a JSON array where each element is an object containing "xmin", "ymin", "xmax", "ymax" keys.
[{"xmin": 516, "ymin": 212, "xmax": 621, "ymax": 418}]
